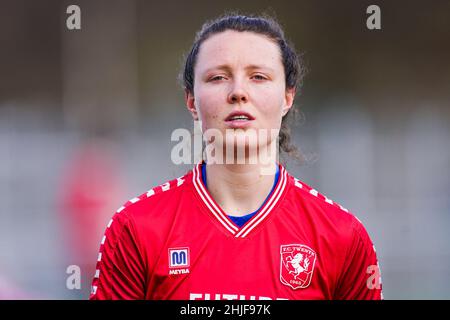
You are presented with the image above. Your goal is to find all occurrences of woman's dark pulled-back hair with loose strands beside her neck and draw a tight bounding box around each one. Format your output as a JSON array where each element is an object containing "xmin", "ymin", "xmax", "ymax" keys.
[{"xmin": 180, "ymin": 14, "xmax": 304, "ymax": 162}]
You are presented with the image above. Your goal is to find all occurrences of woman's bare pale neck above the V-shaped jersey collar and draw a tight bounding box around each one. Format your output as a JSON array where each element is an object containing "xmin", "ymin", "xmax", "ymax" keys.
[{"xmin": 206, "ymin": 159, "xmax": 276, "ymax": 216}]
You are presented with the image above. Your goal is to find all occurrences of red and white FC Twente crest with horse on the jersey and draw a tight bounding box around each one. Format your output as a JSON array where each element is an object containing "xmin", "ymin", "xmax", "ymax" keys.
[{"xmin": 280, "ymin": 244, "xmax": 316, "ymax": 290}]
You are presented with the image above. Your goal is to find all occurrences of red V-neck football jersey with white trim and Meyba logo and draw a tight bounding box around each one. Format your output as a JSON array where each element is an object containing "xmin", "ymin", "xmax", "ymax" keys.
[{"xmin": 90, "ymin": 165, "xmax": 382, "ymax": 300}]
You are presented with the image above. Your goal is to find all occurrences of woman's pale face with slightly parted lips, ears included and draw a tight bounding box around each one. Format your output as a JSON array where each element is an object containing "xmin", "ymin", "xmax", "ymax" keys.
[{"xmin": 186, "ymin": 30, "xmax": 295, "ymax": 154}]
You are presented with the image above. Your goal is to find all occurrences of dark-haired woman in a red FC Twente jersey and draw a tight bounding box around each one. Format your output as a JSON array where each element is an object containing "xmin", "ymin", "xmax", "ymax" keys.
[{"xmin": 91, "ymin": 15, "xmax": 381, "ymax": 300}]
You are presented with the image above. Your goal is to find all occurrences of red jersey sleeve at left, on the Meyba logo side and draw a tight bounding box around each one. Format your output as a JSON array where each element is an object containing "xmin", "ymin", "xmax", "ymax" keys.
[{"xmin": 89, "ymin": 211, "xmax": 145, "ymax": 300}]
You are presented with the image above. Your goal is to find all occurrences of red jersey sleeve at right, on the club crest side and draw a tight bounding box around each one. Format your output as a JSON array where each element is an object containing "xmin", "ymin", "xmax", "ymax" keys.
[{"xmin": 335, "ymin": 218, "xmax": 383, "ymax": 300}]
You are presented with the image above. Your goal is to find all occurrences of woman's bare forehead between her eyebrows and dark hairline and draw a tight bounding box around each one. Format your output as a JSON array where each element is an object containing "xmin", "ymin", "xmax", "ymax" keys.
[{"xmin": 196, "ymin": 30, "xmax": 283, "ymax": 71}]
